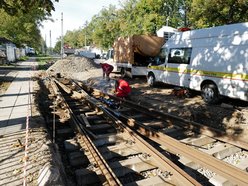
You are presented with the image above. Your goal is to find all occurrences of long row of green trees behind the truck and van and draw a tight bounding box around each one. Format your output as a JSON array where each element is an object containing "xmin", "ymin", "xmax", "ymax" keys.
[{"xmin": 55, "ymin": 0, "xmax": 248, "ymax": 51}]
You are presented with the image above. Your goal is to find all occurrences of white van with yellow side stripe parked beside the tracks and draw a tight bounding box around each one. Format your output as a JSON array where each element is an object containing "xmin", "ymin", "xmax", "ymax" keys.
[{"xmin": 147, "ymin": 22, "xmax": 248, "ymax": 103}]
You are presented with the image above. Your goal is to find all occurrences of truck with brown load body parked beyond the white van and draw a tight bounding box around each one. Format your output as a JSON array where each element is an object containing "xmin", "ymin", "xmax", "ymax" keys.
[{"xmin": 104, "ymin": 35, "xmax": 165, "ymax": 78}]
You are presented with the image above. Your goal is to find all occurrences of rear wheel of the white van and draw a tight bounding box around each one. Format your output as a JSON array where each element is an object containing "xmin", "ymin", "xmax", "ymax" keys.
[{"xmin": 201, "ymin": 84, "xmax": 219, "ymax": 104}]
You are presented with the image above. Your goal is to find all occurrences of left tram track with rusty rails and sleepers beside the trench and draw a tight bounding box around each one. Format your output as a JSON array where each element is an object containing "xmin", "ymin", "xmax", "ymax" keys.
[{"xmin": 46, "ymin": 76, "xmax": 201, "ymax": 185}]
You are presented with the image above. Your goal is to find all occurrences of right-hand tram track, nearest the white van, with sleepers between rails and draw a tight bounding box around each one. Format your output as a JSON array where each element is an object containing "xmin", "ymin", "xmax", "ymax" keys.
[{"xmin": 74, "ymin": 77, "xmax": 247, "ymax": 185}]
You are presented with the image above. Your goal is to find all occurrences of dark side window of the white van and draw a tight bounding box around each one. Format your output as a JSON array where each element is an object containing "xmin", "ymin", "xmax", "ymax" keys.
[{"xmin": 168, "ymin": 48, "xmax": 192, "ymax": 64}]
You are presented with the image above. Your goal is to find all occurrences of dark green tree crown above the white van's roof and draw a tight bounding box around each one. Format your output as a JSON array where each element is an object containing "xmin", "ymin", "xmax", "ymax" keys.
[{"xmin": 189, "ymin": 0, "xmax": 248, "ymax": 28}]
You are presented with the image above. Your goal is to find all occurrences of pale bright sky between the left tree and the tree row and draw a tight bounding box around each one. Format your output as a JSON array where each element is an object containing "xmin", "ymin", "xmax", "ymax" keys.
[{"xmin": 40, "ymin": 0, "xmax": 119, "ymax": 47}]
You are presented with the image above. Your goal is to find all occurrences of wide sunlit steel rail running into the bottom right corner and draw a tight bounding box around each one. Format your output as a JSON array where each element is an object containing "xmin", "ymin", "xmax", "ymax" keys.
[{"xmin": 126, "ymin": 118, "xmax": 248, "ymax": 185}]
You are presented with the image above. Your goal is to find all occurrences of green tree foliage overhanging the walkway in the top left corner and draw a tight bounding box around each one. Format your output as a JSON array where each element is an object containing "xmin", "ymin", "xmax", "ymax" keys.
[{"xmin": 0, "ymin": 0, "xmax": 58, "ymax": 50}]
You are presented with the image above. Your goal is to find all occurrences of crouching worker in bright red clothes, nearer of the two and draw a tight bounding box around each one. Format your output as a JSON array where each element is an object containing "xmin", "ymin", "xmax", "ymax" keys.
[{"xmin": 115, "ymin": 79, "xmax": 131, "ymax": 98}]
